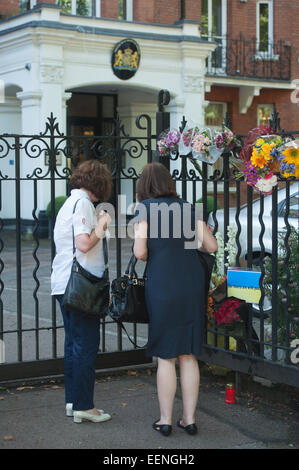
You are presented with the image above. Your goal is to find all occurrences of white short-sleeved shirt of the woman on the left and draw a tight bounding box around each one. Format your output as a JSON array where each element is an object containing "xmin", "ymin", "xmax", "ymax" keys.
[{"xmin": 51, "ymin": 189, "xmax": 108, "ymax": 295}]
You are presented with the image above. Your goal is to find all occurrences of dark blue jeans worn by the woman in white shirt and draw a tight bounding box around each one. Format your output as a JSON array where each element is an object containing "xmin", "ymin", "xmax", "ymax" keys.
[{"xmin": 56, "ymin": 295, "xmax": 100, "ymax": 410}]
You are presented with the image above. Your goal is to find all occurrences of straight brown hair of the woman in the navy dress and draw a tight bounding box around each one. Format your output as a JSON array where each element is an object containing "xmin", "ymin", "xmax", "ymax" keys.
[{"xmin": 137, "ymin": 162, "xmax": 179, "ymax": 201}]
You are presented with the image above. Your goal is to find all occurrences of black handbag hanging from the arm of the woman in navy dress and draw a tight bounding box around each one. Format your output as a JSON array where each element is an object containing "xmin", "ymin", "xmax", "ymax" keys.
[{"xmin": 108, "ymin": 255, "xmax": 149, "ymax": 348}]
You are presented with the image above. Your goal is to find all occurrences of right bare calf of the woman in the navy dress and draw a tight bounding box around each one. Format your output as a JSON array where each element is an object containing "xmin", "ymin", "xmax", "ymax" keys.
[{"xmin": 179, "ymin": 354, "xmax": 200, "ymax": 426}]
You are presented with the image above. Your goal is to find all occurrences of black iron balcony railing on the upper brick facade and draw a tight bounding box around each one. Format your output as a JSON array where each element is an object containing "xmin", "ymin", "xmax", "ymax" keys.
[{"xmin": 203, "ymin": 34, "xmax": 291, "ymax": 80}]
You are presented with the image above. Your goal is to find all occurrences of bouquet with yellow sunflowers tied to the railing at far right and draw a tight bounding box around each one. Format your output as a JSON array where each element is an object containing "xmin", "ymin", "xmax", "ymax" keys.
[{"xmin": 233, "ymin": 126, "xmax": 299, "ymax": 195}]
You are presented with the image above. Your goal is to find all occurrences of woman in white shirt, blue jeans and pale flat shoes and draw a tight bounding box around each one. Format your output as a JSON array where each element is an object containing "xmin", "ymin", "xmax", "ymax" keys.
[{"xmin": 51, "ymin": 160, "xmax": 112, "ymax": 423}]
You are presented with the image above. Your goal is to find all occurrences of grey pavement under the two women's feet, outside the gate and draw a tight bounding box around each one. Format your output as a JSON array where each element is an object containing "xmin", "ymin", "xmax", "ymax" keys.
[{"xmin": 0, "ymin": 368, "xmax": 299, "ymax": 451}]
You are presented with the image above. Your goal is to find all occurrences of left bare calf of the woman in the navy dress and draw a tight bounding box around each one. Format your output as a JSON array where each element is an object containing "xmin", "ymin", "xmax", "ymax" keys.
[{"xmin": 157, "ymin": 357, "xmax": 177, "ymax": 424}]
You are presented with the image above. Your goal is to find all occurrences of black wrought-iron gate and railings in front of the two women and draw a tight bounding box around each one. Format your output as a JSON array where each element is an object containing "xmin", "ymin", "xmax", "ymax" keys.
[{"xmin": 0, "ymin": 90, "xmax": 299, "ymax": 386}]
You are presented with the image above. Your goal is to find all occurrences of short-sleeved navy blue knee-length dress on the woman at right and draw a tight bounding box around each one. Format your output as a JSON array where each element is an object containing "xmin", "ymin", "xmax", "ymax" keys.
[{"xmin": 134, "ymin": 198, "xmax": 205, "ymax": 359}]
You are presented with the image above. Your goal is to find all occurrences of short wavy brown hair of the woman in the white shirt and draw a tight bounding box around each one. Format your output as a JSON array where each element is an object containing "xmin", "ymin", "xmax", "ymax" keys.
[{"xmin": 70, "ymin": 160, "xmax": 112, "ymax": 202}]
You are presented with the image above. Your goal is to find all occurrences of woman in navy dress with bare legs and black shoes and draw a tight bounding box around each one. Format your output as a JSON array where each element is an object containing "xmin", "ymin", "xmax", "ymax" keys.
[{"xmin": 134, "ymin": 163, "xmax": 218, "ymax": 436}]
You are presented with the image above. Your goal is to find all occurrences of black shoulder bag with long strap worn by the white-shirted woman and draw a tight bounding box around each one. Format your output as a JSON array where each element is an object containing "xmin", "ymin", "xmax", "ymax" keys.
[{"xmin": 62, "ymin": 199, "xmax": 110, "ymax": 318}]
